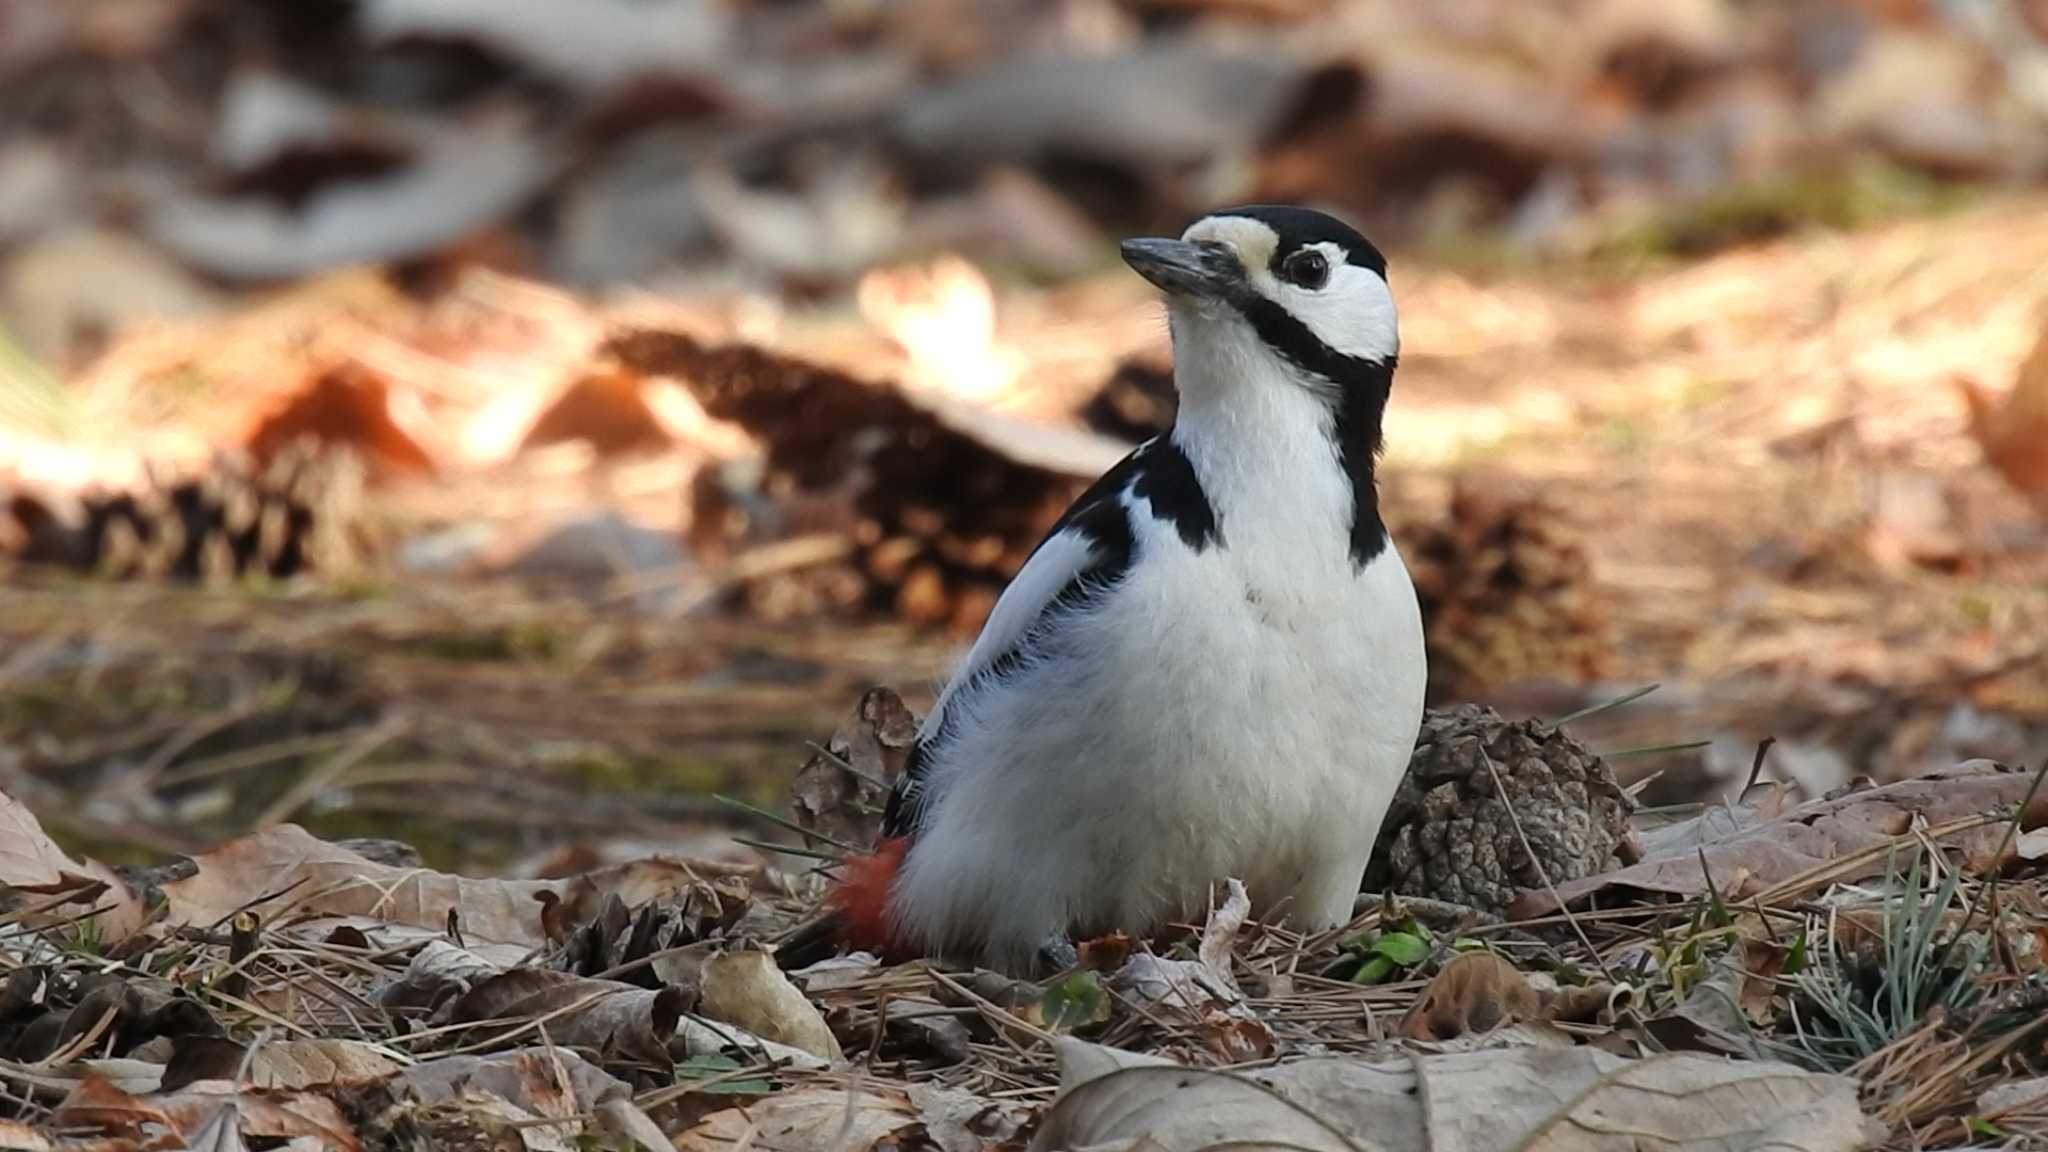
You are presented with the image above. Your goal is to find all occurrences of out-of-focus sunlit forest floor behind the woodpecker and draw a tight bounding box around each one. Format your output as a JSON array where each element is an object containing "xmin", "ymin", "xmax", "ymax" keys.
[{"xmin": 0, "ymin": 0, "xmax": 2048, "ymax": 875}]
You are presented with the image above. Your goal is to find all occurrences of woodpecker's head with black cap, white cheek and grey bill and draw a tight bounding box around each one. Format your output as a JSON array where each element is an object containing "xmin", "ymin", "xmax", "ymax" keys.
[{"xmin": 1122, "ymin": 205, "xmax": 1401, "ymax": 392}]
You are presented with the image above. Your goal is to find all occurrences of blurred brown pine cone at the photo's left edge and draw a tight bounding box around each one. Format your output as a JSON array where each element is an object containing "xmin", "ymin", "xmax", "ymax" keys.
[{"xmin": 0, "ymin": 441, "xmax": 362, "ymax": 582}]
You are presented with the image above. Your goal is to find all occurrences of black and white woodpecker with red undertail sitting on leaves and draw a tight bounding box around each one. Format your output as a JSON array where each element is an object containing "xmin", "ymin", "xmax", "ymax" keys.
[{"xmin": 782, "ymin": 205, "xmax": 1425, "ymax": 972}]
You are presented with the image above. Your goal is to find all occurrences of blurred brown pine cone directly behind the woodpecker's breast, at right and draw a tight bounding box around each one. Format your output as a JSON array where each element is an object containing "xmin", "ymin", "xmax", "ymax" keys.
[{"xmin": 1397, "ymin": 482, "xmax": 1608, "ymax": 699}]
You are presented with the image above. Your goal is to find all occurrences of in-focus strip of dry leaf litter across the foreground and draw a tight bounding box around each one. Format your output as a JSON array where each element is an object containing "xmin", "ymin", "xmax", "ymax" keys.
[{"xmin": 0, "ymin": 701, "xmax": 2048, "ymax": 1150}]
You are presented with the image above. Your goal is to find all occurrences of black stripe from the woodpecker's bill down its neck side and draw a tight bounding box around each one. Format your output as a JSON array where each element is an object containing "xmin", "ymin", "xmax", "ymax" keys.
[{"xmin": 1239, "ymin": 295, "xmax": 1395, "ymax": 568}]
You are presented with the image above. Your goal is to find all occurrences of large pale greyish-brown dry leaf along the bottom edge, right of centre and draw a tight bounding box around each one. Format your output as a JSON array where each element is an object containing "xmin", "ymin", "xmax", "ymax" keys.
[{"xmin": 1032, "ymin": 1039, "xmax": 1864, "ymax": 1152}]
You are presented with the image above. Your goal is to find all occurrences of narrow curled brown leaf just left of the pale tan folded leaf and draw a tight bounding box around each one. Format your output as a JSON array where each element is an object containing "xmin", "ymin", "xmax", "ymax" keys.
[{"xmin": 446, "ymin": 968, "xmax": 688, "ymax": 1064}]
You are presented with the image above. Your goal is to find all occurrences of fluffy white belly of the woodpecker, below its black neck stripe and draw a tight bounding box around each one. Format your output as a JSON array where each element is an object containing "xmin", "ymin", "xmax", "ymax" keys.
[{"xmin": 893, "ymin": 528, "xmax": 1423, "ymax": 968}]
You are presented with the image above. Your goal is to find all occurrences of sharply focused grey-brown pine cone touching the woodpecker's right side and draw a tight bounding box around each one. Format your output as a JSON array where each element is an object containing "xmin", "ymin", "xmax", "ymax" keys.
[{"xmin": 1366, "ymin": 705, "xmax": 1634, "ymax": 910}]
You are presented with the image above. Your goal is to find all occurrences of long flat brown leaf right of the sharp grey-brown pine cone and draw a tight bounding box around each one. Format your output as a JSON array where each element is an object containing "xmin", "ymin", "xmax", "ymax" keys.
[{"xmin": 1507, "ymin": 760, "xmax": 2048, "ymax": 918}]
